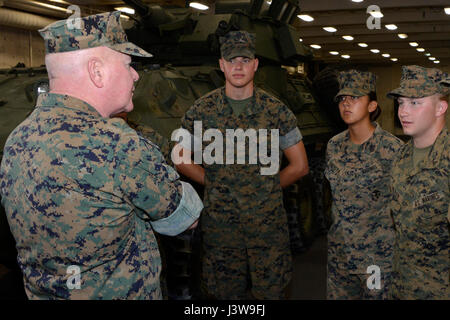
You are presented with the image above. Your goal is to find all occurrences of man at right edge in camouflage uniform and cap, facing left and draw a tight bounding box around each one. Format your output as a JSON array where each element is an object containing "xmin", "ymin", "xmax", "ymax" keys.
[{"xmin": 388, "ymin": 66, "xmax": 450, "ymax": 299}]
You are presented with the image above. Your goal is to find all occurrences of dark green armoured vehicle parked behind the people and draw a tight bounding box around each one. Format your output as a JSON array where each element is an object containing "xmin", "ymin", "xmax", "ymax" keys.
[{"xmin": 0, "ymin": 0, "xmax": 336, "ymax": 299}]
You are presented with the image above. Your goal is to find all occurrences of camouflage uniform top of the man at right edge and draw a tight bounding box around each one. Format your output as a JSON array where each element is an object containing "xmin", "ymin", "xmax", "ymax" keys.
[{"xmin": 391, "ymin": 128, "xmax": 450, "ymax": 300}]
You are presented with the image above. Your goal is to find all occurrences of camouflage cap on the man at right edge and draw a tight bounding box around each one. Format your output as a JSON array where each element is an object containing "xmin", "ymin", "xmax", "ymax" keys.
[{"xmin": 387, "ymin": 66, "xmax": 447, "ymax": 98}]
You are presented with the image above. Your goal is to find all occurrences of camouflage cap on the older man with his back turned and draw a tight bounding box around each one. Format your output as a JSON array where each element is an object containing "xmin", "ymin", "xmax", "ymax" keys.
[{"xmin": 39, "ymin": 11, "xmax": 153, "ymax": 57}]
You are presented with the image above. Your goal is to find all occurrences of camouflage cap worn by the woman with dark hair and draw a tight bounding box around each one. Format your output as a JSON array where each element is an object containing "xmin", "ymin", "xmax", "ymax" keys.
[{"xmin": 334, "ymin": 70, "xmax": 377, "ymax": 101}]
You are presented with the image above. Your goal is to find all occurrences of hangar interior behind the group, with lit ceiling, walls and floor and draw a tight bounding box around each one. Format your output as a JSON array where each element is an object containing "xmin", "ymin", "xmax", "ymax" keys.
[{"xmin": 0, "ymin": 0, "xmax": 450, "ymax": 300}]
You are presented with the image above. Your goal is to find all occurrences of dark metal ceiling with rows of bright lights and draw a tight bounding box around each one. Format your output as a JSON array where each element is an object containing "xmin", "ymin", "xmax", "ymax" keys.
[{"xmin": 0, "ymin": 0, "xmax": 450, "ymax": 66}]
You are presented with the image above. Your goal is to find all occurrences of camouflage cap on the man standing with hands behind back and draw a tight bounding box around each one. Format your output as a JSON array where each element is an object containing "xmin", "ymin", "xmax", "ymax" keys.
[{"xmin": 219, "ymin": 31, "xmax": 255, "ymax": 60}]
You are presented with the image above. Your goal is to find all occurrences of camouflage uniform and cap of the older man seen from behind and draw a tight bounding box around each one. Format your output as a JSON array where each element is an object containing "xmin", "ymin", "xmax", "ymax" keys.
[{"xmin": 0, "ymin": 12, "xmax": 202, "ymax": 299}]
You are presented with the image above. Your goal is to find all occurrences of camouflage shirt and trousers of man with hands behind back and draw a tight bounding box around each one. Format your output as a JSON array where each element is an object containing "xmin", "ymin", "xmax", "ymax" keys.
[{"xmin": 182, "ymin": 87, "xmax": 300, "ymax": 299}]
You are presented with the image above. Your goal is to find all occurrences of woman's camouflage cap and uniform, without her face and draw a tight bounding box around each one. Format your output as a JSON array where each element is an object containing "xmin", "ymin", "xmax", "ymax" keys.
[{"xmin": 325, "ymin": 70, "xmax": 402, "ymax": 299}]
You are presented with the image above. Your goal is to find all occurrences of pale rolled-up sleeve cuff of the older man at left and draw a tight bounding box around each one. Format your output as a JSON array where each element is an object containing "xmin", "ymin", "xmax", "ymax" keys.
[{"xmin": 150, "ymin": 181, "xmax": 203, "ymax": 236}]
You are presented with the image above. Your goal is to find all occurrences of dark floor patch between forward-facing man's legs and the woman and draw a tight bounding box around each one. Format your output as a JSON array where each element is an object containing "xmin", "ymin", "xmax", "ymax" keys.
[{"xmin": 289, "ymin": 235, "xmax": 327, "ymax": 300}]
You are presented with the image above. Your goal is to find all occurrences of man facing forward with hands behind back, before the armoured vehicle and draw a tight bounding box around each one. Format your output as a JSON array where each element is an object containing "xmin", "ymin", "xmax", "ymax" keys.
[{"xmin": 172, "ymin": 31, "xmax": 308, "ymax": 299}]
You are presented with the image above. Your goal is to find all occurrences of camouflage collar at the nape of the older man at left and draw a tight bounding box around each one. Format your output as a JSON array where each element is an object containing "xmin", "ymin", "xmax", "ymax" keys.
[{"xmin": 36, "ymin": 93, "xmax": 102, "ymax": 117}]
